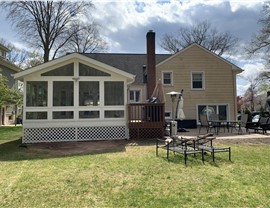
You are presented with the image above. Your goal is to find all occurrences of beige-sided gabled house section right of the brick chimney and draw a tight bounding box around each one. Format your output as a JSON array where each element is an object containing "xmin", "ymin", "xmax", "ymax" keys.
[{"xmin": 156, "ymin": 44, "xmax": 243, "ymax": 123}]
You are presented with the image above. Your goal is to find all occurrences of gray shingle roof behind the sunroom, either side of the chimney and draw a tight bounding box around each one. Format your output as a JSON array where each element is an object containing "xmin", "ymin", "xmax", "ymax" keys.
[{"xmin": 83, "ymin": 53, "xmax": 171, "ymax": 83}]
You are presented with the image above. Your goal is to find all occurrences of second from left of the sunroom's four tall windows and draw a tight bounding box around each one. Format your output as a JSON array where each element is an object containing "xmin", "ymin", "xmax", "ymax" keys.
[{"xmin": 53, "ymin": 81, "xmax": 73, "ymax": 106}]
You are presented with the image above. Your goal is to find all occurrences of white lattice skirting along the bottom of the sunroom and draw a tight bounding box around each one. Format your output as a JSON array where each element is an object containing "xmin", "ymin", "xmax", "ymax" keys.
[{"xmin": 22, "ymin": 126, "xmax": 129, "ymax": 143}]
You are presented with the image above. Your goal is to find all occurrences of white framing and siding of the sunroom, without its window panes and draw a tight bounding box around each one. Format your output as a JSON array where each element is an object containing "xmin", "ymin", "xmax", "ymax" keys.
[{"xmin": 16, "ymin": 54, "xmax": 133, "ymax": 143}]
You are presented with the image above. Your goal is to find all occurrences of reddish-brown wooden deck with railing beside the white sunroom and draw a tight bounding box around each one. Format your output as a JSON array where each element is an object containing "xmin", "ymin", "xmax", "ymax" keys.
[{"xmin": 128, "ymin": 103, "xmax": 165, "ymax": 139}]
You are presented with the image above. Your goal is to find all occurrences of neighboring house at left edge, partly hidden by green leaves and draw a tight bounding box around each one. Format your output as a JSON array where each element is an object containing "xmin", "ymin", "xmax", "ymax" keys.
[{"xmin": 0, "ymin": 44, "xmax": 21, "ymax": 125}]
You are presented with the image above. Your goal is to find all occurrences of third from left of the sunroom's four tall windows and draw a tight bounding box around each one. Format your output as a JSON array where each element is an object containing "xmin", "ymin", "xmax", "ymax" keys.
[{"xmin": 79, "ymin": 81, "xmax": 99, "ymax": 106}]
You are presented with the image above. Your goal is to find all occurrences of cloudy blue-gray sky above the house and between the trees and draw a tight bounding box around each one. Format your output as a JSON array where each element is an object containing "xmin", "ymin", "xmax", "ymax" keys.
[{"xmin": 0, "ymin": 0, "xmax": 264, "ymax": 95}]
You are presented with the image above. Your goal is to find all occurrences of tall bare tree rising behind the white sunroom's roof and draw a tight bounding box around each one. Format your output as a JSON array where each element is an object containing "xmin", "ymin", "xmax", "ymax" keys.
[{"xmin": 0, "ymin": 1, "xmax": 106, "ymax": 62}]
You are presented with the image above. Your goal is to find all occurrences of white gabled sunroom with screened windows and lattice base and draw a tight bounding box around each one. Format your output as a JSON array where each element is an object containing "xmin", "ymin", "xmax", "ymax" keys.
[{"xmin": 15, "ymin": 54, "xmax": 134, "ymax": 143}]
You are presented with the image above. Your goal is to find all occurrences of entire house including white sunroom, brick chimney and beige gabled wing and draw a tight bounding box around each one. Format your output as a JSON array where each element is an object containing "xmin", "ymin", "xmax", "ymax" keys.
[{"xmin": 14, "ymin": 31, "xmax": 242, "ymax": 143}]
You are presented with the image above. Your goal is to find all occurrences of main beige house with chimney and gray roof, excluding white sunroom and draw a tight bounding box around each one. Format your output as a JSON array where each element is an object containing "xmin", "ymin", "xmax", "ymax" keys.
[{"xmin": 88, "ymin": 31, "xmax": 243, "ymax": 125}]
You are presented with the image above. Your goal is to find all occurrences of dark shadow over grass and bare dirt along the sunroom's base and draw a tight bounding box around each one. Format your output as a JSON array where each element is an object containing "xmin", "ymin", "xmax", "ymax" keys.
[{"xmin": 0, "ymin": 139, "xmax": 127, "ymax": 161}]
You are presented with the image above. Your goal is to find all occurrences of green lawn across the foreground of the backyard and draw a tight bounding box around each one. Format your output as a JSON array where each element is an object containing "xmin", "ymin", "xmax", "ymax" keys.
[{"xmin": 0, "ymin": 127, "xmax": 270, "ymax": 207}]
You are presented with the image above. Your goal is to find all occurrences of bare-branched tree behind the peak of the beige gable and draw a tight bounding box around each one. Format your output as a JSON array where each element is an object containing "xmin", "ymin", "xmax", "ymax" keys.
[{"xmin": 160, "ymin": 21, "xmax": 238, "ymax": 56}]
